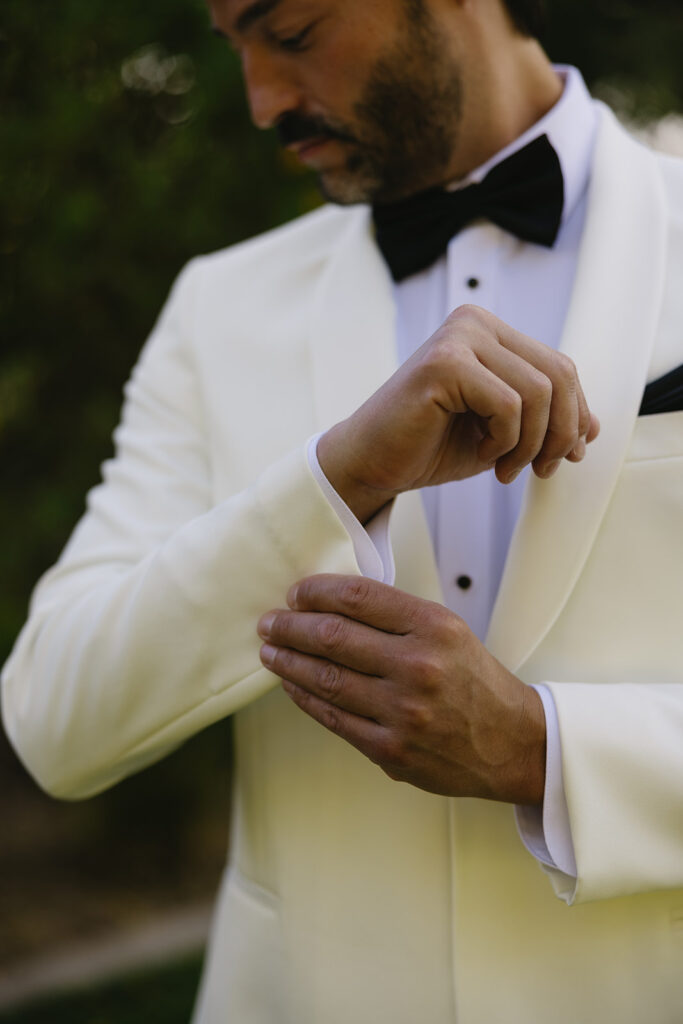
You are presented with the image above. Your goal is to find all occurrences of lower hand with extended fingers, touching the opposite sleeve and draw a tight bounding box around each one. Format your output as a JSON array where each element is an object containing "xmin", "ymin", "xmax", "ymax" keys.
[{"xmin": 258, "ymin": 575, "xmax": 546, "ymax": 804}]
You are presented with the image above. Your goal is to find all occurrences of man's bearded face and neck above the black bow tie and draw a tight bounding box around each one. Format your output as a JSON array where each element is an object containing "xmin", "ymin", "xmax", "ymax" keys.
[{"xmin": 209, "ymin": 0, "xmax": 561, "ymax": 203}]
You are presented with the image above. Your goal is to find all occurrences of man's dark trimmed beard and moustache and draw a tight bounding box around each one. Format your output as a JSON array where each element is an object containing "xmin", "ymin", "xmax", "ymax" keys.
[{"xmin": 278, "ymin": 0, "xmax": 462, "ymax": 205}]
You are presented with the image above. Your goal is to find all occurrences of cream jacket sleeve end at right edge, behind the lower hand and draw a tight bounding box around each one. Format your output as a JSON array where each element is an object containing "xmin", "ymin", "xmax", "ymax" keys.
[{"xmin": 547, "ymin": 682, "xmax": 683, "ymax": 903}]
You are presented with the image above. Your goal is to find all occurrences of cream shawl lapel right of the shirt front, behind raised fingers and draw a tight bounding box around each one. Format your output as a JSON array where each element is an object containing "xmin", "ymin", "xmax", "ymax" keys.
[{"xmin": 487, "ymin": 109, "xmax": 667, "ymax": 671}]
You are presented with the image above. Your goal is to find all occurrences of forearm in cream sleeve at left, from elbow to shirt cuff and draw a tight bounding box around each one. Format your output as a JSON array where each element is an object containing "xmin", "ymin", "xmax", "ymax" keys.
[{"xmin": 3, "ymin": 450, "xmax": 356, "ymax": 797}]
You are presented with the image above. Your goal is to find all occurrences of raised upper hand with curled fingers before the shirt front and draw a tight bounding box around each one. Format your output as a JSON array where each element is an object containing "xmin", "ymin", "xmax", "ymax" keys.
[{"xmin": 317, "ymin": 305, "xmax": 599, "ymax": 522}]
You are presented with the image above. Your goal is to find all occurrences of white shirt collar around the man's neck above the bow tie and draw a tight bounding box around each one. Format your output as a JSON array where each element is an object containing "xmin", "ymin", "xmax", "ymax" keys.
[{"xmin": 447, "ymin": 66, "xmax": 597, "ymax": 234}]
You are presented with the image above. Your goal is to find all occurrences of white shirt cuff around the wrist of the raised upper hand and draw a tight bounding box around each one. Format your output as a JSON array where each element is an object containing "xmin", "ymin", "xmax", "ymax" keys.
[{"xmin": 306, "ymin": 432, "xmax": 396, "ymax": 585}]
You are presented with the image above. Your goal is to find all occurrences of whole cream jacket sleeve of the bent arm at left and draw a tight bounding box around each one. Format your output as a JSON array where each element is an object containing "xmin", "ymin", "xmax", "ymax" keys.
[{"xmin": 2, "ymin": 264, "xmax": 358, "ymax": 799}]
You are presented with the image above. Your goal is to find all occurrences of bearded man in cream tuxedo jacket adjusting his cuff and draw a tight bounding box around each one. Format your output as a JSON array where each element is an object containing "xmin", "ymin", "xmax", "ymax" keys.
[{"xmin": 3, "ymin": 0, "xmax": 683, "ymax": 1024}]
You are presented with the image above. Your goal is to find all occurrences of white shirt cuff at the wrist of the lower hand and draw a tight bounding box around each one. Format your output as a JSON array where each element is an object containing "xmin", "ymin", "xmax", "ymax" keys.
[{"xmin": 515, "ymin": 685, "xmax": 577, "ymax": 903}]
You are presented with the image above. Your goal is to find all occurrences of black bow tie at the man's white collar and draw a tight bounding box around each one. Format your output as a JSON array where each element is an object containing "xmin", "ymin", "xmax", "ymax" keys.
[{"xmin": 373, "ymin": 135, "xmax": 564, "ymax": 281}]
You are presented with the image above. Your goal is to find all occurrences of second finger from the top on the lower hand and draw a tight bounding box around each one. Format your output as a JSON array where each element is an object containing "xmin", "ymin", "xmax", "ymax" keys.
[{"xmin": 258, "ymin": 609, "xmax": 399, "ymax": 676}]
